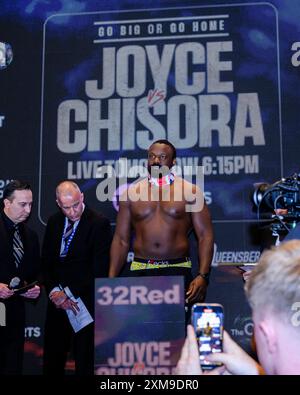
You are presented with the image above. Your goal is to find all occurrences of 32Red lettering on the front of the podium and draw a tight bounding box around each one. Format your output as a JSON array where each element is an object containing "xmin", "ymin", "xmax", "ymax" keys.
[{"xmin": 97, "ymin": 285, "xmax": 180, "ymax": 306}]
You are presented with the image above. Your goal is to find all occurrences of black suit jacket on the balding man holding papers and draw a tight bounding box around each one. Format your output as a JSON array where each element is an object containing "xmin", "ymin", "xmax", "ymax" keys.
[{"xmin": 42, "ymin": 206, "xmax": 112, "ymax": 309}]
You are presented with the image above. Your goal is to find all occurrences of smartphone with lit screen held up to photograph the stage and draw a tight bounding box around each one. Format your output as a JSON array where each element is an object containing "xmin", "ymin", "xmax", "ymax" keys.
[{"xmin": 192, "ymin": 303, "xmax": 224, "ymax": 370}]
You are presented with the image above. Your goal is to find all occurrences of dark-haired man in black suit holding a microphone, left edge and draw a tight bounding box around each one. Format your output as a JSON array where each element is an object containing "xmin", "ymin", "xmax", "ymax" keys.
[{"xmin": 0, "ymin": 180, "xmax": 40, "ymax": 375}]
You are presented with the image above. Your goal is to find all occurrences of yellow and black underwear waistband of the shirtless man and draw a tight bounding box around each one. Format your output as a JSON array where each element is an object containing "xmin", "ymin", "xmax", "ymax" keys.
[{"xmin": 130, "ymin": 257, "xmax": 192, "ymax": 270}]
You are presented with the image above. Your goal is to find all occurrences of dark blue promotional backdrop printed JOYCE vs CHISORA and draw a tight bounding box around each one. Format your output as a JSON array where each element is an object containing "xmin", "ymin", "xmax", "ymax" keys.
[{"xmin": 0, "ymin": 0, "xmax": 300, "ymax": 373}]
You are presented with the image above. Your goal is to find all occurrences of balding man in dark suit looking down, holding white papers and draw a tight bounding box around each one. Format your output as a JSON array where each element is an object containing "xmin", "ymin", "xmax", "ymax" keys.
[{"xmin": 42, "ymin": 181, "xmax": 111, "ymax": 375}]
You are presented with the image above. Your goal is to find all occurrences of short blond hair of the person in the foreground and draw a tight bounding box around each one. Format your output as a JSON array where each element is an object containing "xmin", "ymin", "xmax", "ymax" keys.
[{"xmin": 245, "ymin": 240, "xmax": 300, "ymax": 321}]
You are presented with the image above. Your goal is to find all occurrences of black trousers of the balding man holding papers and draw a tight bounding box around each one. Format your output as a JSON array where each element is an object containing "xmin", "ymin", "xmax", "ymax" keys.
[{"xmin": 43, "ymin": 302, "xmax": 94, "ymax": 376}]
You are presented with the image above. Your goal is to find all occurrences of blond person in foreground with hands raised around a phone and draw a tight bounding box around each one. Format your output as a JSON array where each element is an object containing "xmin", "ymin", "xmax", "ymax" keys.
[{"xmin": 177, "ymin": 240, "xmax": 300, "ymax": 375}]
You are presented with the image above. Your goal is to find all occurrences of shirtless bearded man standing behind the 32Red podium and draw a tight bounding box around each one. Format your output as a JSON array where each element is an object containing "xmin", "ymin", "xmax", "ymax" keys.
[{"xmin": 109, "ymin": 140, "xmax": 213, "ymax": 318}]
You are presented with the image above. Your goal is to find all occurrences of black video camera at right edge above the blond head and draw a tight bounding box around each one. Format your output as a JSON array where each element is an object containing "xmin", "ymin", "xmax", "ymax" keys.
[{"xmin": 252, "ymin": 173, "xmax": 300, "ymax": 232}]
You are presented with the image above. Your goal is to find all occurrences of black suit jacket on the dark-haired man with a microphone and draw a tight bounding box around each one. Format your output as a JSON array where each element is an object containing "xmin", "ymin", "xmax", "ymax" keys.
[{"xmin": 0, "ymin": 215, "xmax": 40, "ymax": 324}]
